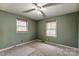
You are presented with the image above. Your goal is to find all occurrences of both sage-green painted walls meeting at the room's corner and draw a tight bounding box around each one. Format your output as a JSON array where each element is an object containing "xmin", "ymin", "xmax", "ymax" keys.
[{"xmin": 0, "ymin": 11, "xmax": 79, "ymax": 49}]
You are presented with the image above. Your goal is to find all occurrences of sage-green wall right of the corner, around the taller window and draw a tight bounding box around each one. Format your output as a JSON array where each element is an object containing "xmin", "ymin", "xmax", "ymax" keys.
[{"xmin": 38, "ymin": 13, "xmax": 78, "ymax": 47}]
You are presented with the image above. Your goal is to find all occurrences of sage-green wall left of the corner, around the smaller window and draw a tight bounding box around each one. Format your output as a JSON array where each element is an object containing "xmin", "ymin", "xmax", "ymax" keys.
[{"xmin": 0, "ymin": 11, "xmax": 36, "ymax": 48}]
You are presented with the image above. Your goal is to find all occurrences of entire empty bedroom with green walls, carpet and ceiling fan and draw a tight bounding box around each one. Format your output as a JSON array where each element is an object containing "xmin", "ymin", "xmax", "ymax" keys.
[{"xmin": 0, "ymin": 3, "xmax": 79, "ymax": 56}]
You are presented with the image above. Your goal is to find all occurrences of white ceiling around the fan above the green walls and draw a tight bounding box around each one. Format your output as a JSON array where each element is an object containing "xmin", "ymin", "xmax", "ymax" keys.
[{"xmin": 0, "ymin": 3, "xmax": 79, "ymax": 20}]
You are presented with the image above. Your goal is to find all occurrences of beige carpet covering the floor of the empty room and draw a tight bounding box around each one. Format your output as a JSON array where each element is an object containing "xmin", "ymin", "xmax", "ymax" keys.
[{"xmin": 0, "ymin": 42, "xmax": 79, "ymax": 56}]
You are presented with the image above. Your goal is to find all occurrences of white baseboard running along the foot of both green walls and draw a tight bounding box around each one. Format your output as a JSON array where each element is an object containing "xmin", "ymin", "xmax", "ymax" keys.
[{"xmin": 0, "ymin": 40, "xmax": 79, "ymax": 52}]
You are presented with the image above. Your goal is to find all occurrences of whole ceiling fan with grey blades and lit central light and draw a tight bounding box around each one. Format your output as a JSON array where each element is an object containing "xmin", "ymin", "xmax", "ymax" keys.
[{"xmin": 23, "ymin": 3, "xmax": 60, "ymax": 18}]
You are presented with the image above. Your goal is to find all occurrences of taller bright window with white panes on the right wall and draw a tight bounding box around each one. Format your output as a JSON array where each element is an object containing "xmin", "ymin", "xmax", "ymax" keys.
[{"xmin": 46, "ymin": 21, "xmax": 56, "ymax": 37}]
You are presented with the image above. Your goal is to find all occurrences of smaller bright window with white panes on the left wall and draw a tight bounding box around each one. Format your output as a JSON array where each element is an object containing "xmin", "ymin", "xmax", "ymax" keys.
[{"xmin": 16, "ymin": 19, "xmax": 28, "ymax": 32}]
